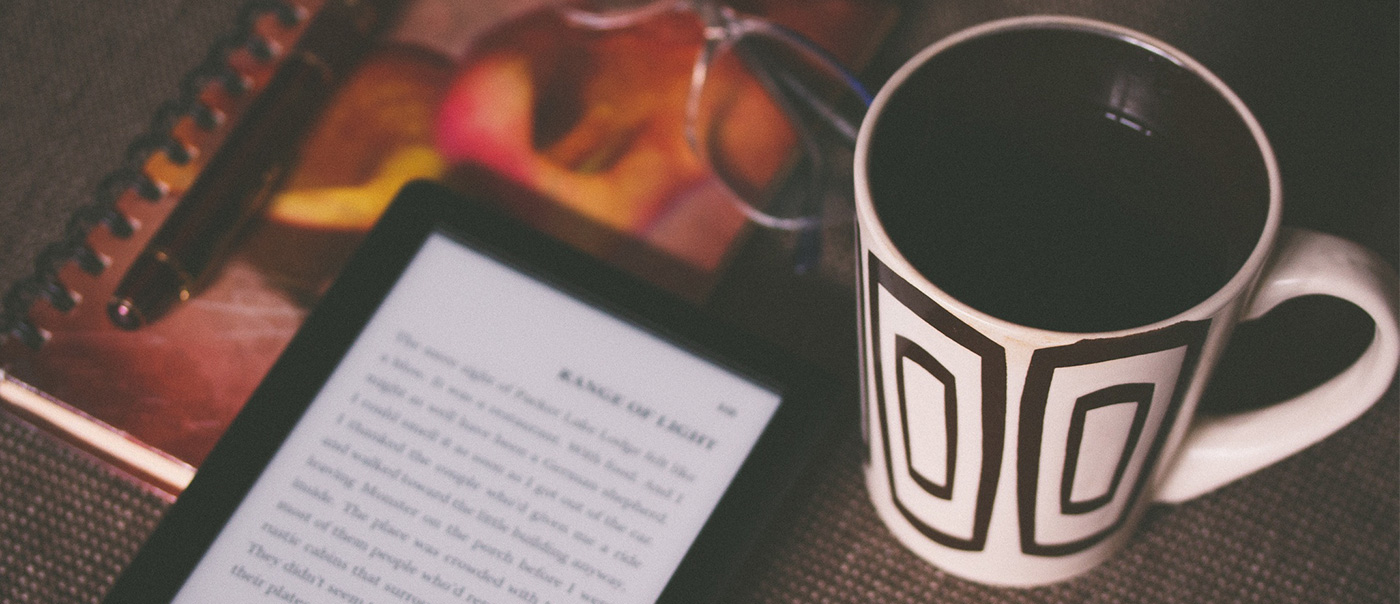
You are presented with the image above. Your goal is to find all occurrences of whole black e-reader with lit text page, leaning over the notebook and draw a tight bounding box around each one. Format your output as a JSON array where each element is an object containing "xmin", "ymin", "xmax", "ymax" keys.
[{"xmin": 106, "ymin": 182, "xmax": 837, "ymax": 604}]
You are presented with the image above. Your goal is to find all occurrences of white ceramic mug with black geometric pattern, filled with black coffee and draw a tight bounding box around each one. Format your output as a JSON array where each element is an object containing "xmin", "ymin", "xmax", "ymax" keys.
[{"xmin": 854, "ymin": 17, "xmax": 1400, "ymax": 586}]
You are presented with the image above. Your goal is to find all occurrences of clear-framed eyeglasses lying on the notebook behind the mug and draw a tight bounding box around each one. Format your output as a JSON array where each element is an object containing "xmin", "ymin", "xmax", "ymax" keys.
[{"xmin": 560, "ymin": 0, "xmax": 871, "ymax": 272}]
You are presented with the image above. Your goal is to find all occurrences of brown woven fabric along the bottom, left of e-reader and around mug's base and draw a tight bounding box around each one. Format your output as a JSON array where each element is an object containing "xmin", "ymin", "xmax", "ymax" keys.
[{"xmin": 0, "ymin": 399, "xmax": 1400, "ymax": 603}]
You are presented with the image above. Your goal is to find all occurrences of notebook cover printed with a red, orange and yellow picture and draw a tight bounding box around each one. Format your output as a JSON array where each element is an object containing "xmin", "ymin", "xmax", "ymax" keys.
[{"xmin": 0, "ymin": 0, "xmax": 892, "ymax": 476}]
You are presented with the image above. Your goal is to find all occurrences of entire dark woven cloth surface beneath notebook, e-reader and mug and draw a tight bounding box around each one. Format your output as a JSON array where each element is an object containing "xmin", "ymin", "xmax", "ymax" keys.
[{"xmin": 0, "ymin": 0, "xmax": 1400, "ymax": 603}]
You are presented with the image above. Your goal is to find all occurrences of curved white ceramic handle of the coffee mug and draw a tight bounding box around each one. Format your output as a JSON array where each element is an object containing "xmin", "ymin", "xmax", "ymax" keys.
[{"xmin": 1156, "ymin": 227, "xmax": 1400, "ymax": 503}]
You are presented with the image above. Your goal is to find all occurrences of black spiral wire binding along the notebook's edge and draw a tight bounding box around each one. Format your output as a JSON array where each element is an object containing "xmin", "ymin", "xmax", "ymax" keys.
[{"xmin": 0, "ymin": 0, "xmax": 308, "ymax": 350}]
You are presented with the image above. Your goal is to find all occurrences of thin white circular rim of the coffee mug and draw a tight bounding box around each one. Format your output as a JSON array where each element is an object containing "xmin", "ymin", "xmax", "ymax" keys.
[{"xmin": 853, "ymin": 15, "xmax": 1282, "ymax": 338}]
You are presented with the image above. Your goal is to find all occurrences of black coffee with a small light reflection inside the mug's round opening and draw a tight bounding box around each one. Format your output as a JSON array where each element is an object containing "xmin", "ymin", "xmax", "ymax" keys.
[{"xmin": 868, "ymin": 29, "xmax": 1268, "ymax": 332}]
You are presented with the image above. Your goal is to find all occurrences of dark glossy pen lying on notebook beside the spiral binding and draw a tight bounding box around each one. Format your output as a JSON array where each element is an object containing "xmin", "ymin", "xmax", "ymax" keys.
[{"xmin": 108, "ymin": 0, "xmax": 399, "ymax": 329}]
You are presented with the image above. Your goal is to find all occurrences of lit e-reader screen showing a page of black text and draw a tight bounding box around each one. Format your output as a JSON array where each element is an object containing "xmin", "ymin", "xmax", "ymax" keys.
[{"xmin": 175, "ymin": 233, "xmax": 781, "ymax": 604}]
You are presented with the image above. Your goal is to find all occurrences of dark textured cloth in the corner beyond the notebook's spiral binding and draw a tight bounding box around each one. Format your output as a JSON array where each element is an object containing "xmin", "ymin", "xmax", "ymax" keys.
[{"xmin": 0, "ymin": 0, "xmax": 249, "ymax": 298}]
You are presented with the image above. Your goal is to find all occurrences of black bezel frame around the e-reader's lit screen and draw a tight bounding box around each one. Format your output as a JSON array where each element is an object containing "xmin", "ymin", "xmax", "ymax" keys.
[{"xmin": 104, "ymin": 182, "xmax": 839, "ymax": 604}]
